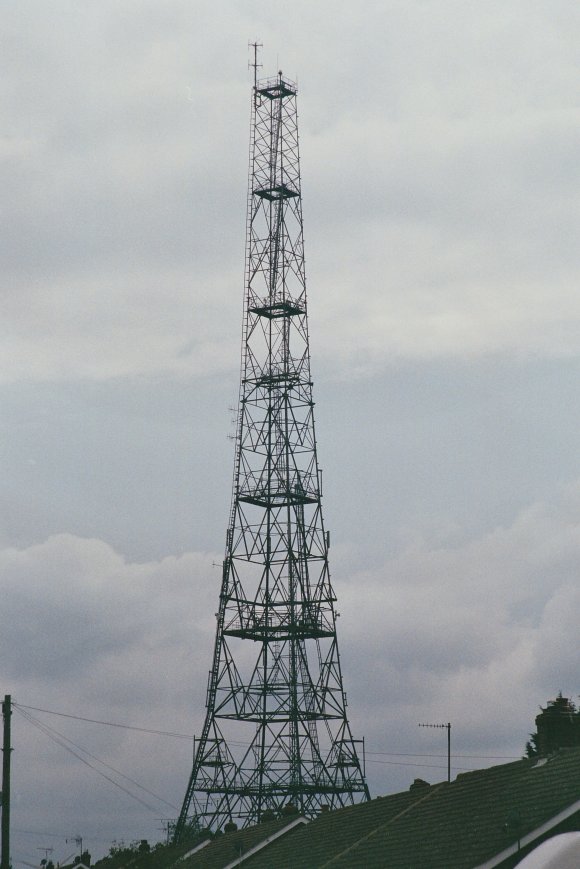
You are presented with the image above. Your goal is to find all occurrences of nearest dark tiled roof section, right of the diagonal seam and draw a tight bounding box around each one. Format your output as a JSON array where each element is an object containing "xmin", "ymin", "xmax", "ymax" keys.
[{"xmin": 323, "ymin": 749, "xmax": 580, "ymax": 869}]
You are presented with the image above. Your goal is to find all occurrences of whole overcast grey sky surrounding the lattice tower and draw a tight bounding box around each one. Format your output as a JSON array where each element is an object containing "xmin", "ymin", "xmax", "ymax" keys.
[{"xmin": 0, "ymin": 0, "xmax": 580, "ymax": 866}]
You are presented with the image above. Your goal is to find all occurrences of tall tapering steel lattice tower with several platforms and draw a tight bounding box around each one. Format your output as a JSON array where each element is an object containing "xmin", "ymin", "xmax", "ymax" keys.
[{"xmin": 175, "ymin": 64, "xmax": 369, "ymax": 839}]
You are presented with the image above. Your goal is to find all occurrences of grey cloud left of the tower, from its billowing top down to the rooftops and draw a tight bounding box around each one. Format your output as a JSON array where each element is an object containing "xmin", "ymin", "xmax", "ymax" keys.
[{"xmin": 0, "ymin": 534, "xmax": 219, "ymax": 857}]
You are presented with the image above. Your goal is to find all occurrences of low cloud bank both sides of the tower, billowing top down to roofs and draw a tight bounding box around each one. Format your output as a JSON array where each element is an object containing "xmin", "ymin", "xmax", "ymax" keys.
[{"xmin": 0, "ymin": 484, "xmax": 580, "ymax": 852}]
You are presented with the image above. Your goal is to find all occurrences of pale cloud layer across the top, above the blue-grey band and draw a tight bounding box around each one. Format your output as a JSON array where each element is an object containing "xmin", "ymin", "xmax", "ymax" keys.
[{"xmin": 2, "ymin": 2, "xmax": 578, "ymax": 379}]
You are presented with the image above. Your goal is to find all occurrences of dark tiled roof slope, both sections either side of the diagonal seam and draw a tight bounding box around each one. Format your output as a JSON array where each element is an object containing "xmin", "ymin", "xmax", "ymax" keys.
[{"xmin": 243, "ymin": 748, "xmax": 580, "ymax": 869}]
